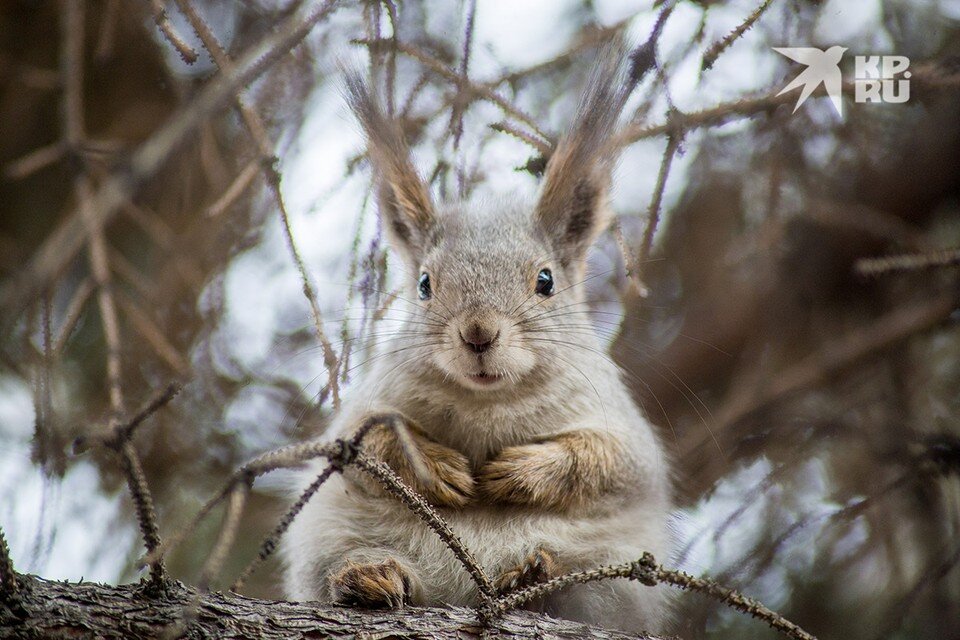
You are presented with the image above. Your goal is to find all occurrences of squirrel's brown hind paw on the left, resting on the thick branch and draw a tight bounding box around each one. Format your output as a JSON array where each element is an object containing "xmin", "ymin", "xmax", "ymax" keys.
[{"xmin": 330, "ymin": 558, "xmax": 410, "ymax": 609}]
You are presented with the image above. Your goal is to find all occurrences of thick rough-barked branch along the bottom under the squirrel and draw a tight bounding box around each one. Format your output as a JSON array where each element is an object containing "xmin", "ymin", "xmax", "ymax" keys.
[{"xmin": 0, "ymin": 576, "xmax": 659, "ymax": 640}]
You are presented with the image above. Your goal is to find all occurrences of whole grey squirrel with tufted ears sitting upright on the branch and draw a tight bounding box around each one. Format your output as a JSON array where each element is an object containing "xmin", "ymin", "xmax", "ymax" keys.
[{"xmin": 282, "ymin": 51, "xmax": 672, "ymax": 632}]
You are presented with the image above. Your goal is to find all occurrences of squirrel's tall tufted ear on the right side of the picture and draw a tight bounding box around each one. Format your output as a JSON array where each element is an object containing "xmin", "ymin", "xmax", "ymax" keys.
[{"xmin": 534, "ymin": 45, "xmax": 635, "ymax": 266}]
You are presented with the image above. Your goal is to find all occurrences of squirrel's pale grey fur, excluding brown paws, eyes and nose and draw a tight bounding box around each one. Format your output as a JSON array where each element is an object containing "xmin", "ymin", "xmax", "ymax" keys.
[{"xmin": 283, "ymin": 52, "xmax": 671, "ymax": 631}]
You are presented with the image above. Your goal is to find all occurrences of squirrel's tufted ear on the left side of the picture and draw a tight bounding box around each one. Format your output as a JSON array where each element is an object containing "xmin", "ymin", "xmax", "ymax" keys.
[{"xmin": 346, "ymin": 72, "xmax": 436, "ymax": 264}]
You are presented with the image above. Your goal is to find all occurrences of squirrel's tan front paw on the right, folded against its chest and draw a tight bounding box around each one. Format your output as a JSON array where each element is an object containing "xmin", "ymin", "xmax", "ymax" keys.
[{"xmin": 477, "ymin": 442, "xmax": 571, "ymax": 508}]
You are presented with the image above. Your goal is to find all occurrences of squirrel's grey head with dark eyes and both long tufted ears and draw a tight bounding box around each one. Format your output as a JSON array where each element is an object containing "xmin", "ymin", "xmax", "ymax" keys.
[{"xmin": 347, "ymin": 52, "xmax": 629, "ymax": 392}]
